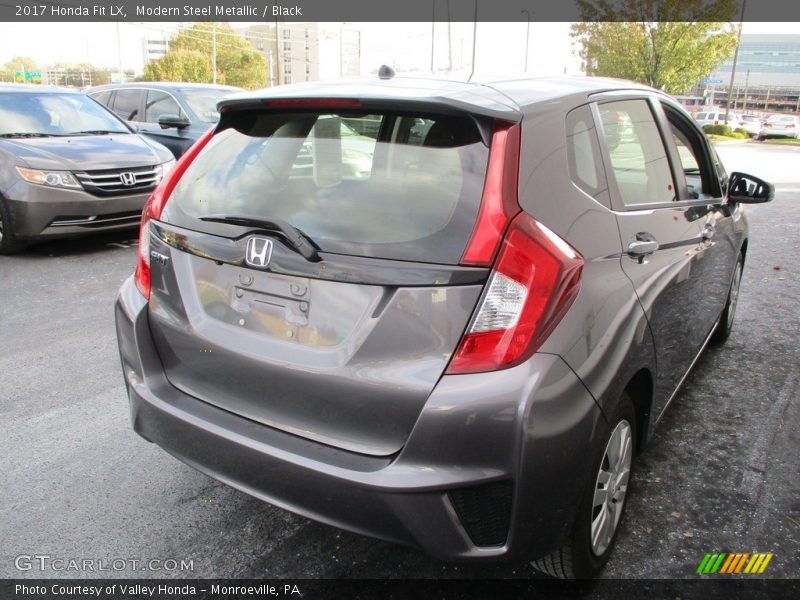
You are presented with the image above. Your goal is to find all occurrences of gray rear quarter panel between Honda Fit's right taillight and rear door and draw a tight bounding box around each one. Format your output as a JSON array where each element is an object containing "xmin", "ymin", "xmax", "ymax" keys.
[{"xmin": 519, "ymin": 98, "xmax": 656, "ymax": 436}]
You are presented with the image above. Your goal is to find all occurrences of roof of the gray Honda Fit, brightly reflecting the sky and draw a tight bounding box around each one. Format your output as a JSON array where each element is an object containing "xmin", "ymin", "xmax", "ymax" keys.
[{"xmin": 218, "ymin": 77, "xmax": 657, "ymax": 119}]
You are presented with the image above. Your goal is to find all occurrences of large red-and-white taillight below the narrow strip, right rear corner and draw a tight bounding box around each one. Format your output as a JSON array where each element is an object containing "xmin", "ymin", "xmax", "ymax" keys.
[{"xmin": 447, "ymin": 213, "xmax": 583, "ymax": 374}]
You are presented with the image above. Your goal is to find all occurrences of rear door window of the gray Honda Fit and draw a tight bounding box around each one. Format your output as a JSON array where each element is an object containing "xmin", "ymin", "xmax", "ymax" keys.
[{"xmin": 599, "ymin": 100, "xmax": 677, "ymax": 207}]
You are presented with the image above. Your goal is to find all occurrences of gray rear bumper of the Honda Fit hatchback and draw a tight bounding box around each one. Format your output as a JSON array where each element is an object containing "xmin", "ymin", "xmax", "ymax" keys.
[{"xmin": 116, "ymin": 279, "xmax": 602, "ymax": 560}]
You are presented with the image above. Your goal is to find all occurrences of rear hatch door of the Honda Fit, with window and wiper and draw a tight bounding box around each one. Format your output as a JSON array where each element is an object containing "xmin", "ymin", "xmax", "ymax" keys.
[{"xmin": 150, "ymin": 108, "xmax": 491, "ymax": 456}]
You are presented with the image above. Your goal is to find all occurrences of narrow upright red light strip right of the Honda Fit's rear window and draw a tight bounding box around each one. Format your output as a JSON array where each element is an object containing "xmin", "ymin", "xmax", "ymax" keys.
[{"xmin": 461, "ymin": 123, "xmax": 520, "ymax": 267}]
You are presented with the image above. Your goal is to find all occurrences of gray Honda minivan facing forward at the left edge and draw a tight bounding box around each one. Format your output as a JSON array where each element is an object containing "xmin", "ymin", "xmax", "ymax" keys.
[{"xmin": 0, "ymin": 84, "xmax": 174, "ymax": 254}]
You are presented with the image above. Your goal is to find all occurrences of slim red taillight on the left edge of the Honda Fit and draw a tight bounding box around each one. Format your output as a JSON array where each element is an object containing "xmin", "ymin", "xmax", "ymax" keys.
[{"xmin": 133, "ymin": 127, "xmax": 214, "ymax": 300}]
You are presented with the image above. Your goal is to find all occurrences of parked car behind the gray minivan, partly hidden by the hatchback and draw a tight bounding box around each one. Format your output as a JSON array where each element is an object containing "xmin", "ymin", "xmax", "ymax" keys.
[{"xmin": 85, "ymin": 82, "xmax": 242, "ymax": 158}]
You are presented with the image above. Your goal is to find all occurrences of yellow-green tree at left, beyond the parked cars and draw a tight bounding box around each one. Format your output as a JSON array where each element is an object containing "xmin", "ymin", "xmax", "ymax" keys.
[{"xmin": 142, "ymin": 23, "xmax": 266, "ymax": 89}]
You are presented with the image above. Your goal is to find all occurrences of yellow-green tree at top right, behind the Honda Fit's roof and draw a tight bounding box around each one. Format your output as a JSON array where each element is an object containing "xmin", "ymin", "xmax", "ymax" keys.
[{"xmin": 572, "ymin": 0, "xmax": 739, "ymax": 94}]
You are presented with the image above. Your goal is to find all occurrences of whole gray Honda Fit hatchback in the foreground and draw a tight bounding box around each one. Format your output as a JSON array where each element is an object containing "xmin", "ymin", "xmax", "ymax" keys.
[{"xmin": 116, "ymin": 78, "xmax": 773, "ymax": 577}]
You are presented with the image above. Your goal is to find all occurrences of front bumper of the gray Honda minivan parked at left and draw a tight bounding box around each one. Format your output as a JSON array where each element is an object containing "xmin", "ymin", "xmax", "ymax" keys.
[{"xmin": 6, "ymin": 182, "xmax": 149, "ymax": 239}]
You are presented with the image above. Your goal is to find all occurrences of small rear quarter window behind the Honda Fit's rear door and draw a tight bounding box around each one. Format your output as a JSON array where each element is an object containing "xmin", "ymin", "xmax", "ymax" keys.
[{"xmin": 566, "ymin": 106, "xmax": 610, "ymax": 206}]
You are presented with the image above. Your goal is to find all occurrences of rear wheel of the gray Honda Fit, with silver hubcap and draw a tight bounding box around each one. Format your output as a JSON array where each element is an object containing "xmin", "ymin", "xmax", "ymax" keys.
[{"xmin": 531, "ymin": 394, "xmax": 636, "ymax": 579}]
